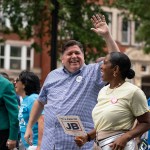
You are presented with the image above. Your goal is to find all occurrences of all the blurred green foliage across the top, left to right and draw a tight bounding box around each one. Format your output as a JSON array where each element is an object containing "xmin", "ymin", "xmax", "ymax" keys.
[{"xmin": 0, "ymin": 0, "xmax": 150, "ymax": 63}]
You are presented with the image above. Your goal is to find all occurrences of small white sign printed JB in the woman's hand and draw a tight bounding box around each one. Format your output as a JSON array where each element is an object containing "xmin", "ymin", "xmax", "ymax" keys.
[{"xmin": 57, "ymin": 116, "xmax": 86, "ymax": 136}]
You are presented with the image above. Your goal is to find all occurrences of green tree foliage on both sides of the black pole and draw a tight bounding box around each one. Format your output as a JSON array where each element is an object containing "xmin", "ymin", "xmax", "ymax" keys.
[{"xmin": 2, "ymin": 0, "xmax": 107, "ymax": 62}]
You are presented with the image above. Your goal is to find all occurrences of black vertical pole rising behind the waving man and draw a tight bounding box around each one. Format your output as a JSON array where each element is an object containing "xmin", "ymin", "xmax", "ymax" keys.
[{"xmin": 51, "ymin": 0, "xmax": 59, "ymax": 70}]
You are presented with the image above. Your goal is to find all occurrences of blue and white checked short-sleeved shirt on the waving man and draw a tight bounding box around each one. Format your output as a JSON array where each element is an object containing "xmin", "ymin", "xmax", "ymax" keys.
[{"xmin": 38, "ymin": 63, "xmax": 104, "ymax": 150}]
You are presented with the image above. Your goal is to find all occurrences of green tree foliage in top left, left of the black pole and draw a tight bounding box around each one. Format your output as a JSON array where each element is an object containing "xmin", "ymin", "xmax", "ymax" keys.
[{"xmin": 2, "ymin": 0, "xmax": 51, "ymax": 39}]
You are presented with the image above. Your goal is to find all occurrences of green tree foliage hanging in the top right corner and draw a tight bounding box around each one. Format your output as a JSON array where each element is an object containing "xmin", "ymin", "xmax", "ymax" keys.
[{"xmin": 105, "ymin": 0, "xmax": 150, "ymax": 53}]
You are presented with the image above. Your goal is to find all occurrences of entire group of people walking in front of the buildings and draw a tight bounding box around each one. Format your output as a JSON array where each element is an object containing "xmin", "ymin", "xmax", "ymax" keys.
[{"xmin": 0, "ymin": 14, "xmax": 150, "ymax": 150}]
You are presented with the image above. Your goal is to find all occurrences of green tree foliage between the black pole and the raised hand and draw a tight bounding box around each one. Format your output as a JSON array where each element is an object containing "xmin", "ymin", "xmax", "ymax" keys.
[{"xmin": 58, "ymin": 0, "xmax": 107, "ymax": 62}]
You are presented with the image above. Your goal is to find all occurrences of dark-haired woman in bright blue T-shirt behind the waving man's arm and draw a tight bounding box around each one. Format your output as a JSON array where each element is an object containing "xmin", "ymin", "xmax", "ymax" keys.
[{"xmin": 15, "ymin": 71, "xmax": 43, "ymax": 149}]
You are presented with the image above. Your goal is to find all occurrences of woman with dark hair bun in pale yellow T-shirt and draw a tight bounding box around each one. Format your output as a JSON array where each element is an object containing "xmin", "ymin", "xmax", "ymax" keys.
[{"xmin": 75, "ymin": 52, "xmax": 150, "ymax": 150}]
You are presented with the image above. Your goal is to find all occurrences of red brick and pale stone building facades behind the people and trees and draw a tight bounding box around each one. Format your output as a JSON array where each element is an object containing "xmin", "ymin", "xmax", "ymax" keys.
[{"xmin": 0, "ymin": 0, "xmax": 150, "ymax": 95}]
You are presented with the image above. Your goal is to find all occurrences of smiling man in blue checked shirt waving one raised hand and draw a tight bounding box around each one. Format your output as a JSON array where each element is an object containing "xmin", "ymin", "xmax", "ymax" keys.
[{"xmin": 25, "ymin": 14, "xmax": 119, "ymax": 150}]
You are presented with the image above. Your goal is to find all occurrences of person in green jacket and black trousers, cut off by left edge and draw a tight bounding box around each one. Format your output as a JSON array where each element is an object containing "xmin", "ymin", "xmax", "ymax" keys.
[{"xmin": 0, "ymin": 75, "xmax": 19, "ymax": 150}]
